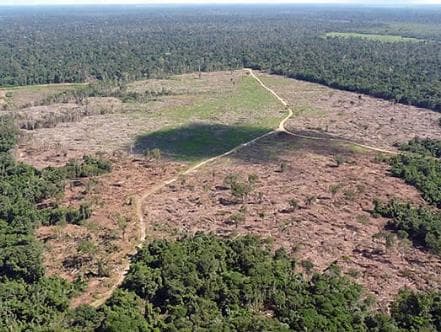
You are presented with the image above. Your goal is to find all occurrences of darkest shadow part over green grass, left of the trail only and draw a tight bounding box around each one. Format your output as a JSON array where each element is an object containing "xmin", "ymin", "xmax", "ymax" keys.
[{"xmin": 133, "ymin": 123, "xmax": 271, "ymax": 161}]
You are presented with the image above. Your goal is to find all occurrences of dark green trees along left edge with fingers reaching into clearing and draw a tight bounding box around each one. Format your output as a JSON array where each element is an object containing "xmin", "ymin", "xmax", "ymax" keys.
[{"xmin": 0, "ymin": 118, "xmax": 108, "ymax": 331}]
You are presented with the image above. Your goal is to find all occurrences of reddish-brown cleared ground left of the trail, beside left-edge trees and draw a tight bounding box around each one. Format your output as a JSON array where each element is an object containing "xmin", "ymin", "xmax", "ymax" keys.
[{"xmin": 37, "ymin": 156, "xmax": 182, "ymax": 304}]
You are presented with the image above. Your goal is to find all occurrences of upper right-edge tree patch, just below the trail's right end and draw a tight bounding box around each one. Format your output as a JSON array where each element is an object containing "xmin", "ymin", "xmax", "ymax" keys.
[{"xmin": 390, "ymin": 139, "xmax": 441, "ymax": 207}]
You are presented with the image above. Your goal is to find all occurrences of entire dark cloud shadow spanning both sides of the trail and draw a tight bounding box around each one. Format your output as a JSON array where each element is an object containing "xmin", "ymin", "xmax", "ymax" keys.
[{"xmin": 134, "ymin": 123, "xmax": 368, "ymax": 163}]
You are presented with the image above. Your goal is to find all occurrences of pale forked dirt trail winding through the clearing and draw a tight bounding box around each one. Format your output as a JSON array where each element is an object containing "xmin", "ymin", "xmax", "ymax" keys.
[{"xmin": 90, "ymin": 69, "xmax": 397, "ymax": 308}]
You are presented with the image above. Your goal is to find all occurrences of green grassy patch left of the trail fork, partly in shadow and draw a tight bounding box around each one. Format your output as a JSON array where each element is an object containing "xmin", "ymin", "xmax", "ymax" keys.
[{"xmin": 134, "ymin": 77, "xmax": 285, "ymax": 162}]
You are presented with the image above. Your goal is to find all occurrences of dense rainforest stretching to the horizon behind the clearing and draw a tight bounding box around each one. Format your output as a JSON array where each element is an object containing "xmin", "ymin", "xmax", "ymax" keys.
[{"xmin": 0, "ymin": 6, "xmax": 441, "ymax": 110}]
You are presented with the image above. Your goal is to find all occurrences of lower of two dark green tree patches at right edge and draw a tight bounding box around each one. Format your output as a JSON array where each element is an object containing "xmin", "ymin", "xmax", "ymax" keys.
[{"xmin": 374, "ymin": 200, "xmax": 441, "ymax": 255}]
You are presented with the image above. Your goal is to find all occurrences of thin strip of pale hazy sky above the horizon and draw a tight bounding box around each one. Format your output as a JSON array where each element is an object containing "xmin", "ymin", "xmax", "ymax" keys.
[{"xmin": 0, "ymin": 0, "xmax": 441, "ymax": 5}]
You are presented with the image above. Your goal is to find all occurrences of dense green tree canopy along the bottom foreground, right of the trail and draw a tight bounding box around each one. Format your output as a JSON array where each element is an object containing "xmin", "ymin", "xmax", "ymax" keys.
[{"xmin": 60, "ymin": 235, "xmax": 441, "ymax": 331}]
